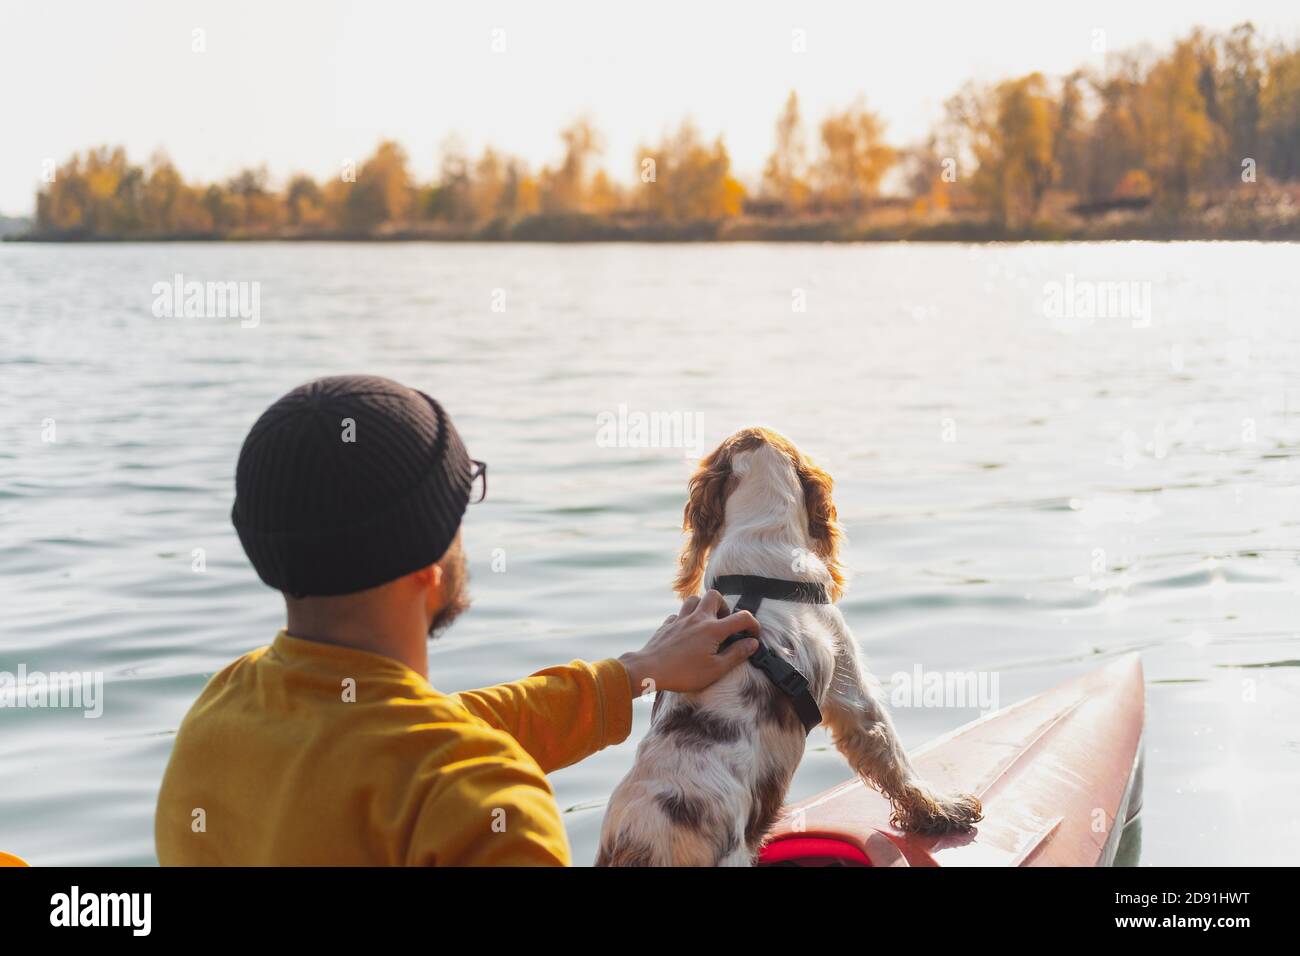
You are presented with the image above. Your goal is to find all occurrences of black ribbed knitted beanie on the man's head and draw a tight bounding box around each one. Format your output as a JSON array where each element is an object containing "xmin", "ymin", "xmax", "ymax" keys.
[{"xmin": 230, "ymin": 375, "xmax": 471, "ymax": 596}]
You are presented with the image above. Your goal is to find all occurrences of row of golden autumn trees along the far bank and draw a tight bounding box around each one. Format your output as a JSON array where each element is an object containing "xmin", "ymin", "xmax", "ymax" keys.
[{"xmin": 29, "ymin": 23, "xmax": 1300, "ymax": 241}]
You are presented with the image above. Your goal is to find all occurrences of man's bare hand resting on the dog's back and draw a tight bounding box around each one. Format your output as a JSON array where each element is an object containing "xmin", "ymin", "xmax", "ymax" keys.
[{"xmin": 619, "ymin": 591, "xmax": 758, "ymax": 697}]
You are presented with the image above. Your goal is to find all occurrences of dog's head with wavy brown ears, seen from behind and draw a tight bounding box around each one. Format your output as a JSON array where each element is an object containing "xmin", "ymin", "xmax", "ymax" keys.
[{"xmin": 673, "ymin": 428, "xmax": 844, "ymax": 600}]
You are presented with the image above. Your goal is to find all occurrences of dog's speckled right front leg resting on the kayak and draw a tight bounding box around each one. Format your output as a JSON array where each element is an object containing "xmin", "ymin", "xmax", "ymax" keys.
[{"xmin": 822, "ymin": 630, "xmax": 982, "ymax": 834}]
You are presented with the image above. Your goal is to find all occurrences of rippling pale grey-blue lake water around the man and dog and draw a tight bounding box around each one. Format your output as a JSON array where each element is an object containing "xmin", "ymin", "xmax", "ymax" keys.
[{"xmin": 0, "ymin": 243, "xmax": 1300, "ymax": 865}]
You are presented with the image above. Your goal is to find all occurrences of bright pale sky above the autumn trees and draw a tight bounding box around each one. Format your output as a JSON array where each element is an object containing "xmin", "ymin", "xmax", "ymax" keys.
[{"xmin": 0, "ymin": 0, "xmax": 1300, "ymax": 215}]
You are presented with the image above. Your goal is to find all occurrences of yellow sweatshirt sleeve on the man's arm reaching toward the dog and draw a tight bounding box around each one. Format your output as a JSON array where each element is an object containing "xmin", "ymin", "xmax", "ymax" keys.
[{"xmin": 454, "ymin": 658, "xmax": 632, "ymax": 773}]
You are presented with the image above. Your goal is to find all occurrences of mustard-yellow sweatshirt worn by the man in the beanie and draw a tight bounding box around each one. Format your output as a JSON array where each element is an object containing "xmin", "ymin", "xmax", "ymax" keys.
[{"xmin": 155, "ymin": 631, "xmax": 632, "ymax": 866}]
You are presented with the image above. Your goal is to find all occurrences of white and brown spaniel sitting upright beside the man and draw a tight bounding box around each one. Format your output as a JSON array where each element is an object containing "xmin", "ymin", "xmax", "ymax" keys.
[{"xmin": 595, "ymin": 428, "xmax": 982, "ymax": 866}]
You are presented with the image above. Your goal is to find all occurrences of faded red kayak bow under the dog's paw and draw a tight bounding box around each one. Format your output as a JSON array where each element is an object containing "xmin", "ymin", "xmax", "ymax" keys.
[{"xmin": 759, "ymin": 654, "xmax": 1145, "ymax": 866}]
